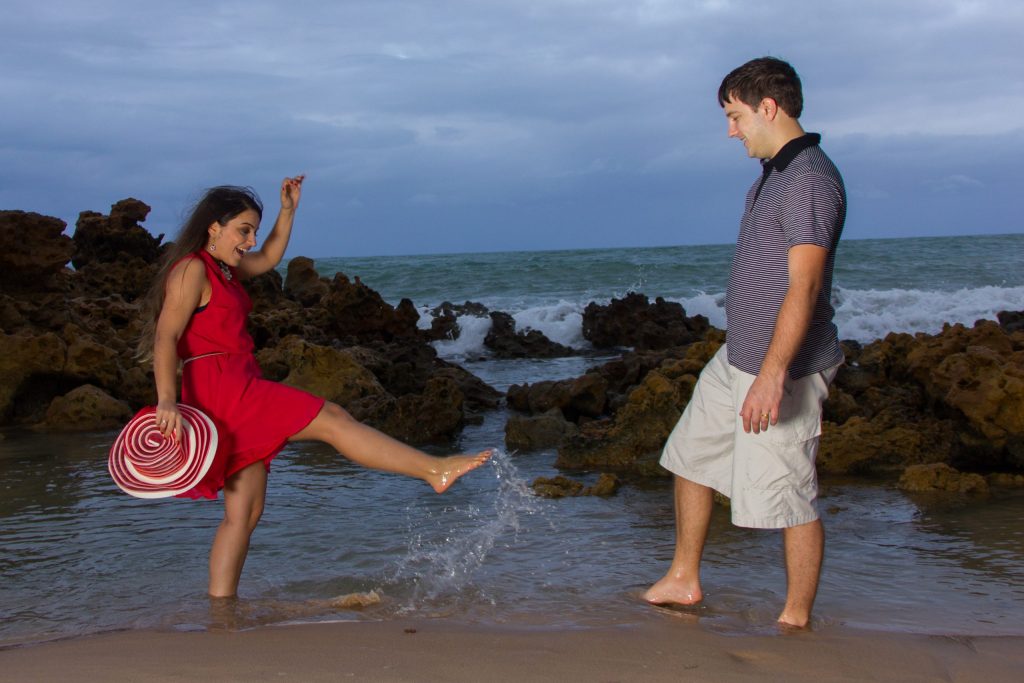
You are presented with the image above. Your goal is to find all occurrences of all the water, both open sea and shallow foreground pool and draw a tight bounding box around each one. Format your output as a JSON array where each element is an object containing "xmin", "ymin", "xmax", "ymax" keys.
[{"xmin": 0, "ymin": 234, "xmax": 1024, "ymax": 646}]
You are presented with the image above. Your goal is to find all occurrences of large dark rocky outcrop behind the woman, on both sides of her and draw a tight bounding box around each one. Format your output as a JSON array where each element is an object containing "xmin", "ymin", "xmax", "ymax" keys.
[{"xmin": 0, "ymin": 200, "xmax": 502, "ymax": 442}]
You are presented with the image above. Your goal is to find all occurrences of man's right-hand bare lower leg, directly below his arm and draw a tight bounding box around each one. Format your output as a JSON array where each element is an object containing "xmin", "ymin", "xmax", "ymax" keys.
[{"xmin": 778, "ymin": 519, "xmax": 825, "ymax": 629}]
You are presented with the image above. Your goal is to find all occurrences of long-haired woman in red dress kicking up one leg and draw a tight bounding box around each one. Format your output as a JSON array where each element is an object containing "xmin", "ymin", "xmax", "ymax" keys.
[{"xmin": 139, "ymin": 175, "xmax": 490, "ymax": 597}]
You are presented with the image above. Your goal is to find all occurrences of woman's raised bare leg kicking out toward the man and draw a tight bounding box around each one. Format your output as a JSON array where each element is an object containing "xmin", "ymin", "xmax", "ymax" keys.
[{"xmin": 289, "ymin": 402, "xmax": 490, "ymax": 494}]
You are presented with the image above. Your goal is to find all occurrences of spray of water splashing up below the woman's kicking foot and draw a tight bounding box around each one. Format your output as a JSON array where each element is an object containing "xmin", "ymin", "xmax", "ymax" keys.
[{"xmin": 389, "ymin": 449, "xmax": 542, "ymax": 611}]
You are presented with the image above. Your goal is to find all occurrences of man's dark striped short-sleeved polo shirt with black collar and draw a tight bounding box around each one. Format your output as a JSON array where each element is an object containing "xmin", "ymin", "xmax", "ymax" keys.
[{"xmin": 725, "ymin": 133, "xmax": 846, "ymax": 379}]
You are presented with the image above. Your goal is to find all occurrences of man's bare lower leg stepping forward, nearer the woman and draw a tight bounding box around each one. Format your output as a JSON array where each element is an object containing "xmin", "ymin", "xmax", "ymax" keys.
[{"xmin": 643, "ymin": 475, "xmax": 713, "ymax": 605}]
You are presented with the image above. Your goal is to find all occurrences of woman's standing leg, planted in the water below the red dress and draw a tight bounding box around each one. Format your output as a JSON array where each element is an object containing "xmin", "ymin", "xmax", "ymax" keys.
[{"xmin": 210, "ymin": 461, "xmax": 266, "ymax": 598}]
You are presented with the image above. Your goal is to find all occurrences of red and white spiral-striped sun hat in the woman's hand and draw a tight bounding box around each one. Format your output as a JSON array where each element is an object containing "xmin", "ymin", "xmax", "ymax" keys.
[{"xmin": 108, "ymin": 403, "xmax": 217, "ymax": 498}]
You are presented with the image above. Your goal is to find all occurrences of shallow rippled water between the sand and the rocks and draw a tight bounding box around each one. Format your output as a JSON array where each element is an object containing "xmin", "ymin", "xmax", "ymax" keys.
[{"xmin": 0, "ymin": 395, "xmax": 1024, "ymax": 644}]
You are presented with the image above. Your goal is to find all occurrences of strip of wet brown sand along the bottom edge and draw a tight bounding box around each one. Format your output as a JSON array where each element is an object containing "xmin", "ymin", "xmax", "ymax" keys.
[{"xmin": 0, "ymin": 617, "xmax": 1024, "ymax": 683}]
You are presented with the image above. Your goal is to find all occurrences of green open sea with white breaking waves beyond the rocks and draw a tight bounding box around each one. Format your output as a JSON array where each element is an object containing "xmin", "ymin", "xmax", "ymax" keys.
[{"xmin": 307, "ymin": 233, "xmax": 1024, "ymax": 359}]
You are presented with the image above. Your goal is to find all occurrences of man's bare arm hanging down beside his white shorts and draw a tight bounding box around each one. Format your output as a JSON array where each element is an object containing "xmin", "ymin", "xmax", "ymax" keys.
[{"xmin": 739, "ymin": 245, "xmax": 828, "ymax": 434}]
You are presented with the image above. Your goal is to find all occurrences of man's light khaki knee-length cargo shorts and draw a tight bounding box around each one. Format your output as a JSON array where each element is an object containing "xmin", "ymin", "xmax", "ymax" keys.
[{"xmin": 660, "ymin": 344, "xmax": 839, "ymax": 528}]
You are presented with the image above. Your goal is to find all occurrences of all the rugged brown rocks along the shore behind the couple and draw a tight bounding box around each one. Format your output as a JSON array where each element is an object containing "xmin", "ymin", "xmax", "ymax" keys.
[{"xmin": 0, "ymin": 200, "xmax": 1024, "ymax": 487}]
